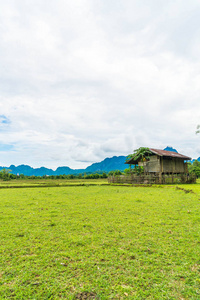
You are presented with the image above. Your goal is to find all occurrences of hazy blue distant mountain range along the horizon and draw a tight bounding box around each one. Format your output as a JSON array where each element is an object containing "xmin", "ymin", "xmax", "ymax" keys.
[{"xmin": 0, "ymin": 147, "xmax": 200, "ymax": 176}]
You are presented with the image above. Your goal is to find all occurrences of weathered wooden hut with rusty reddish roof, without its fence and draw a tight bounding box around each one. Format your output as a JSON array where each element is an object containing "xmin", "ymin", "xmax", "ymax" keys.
[{"xmin": 126, "ymin": 148, "xmax": 191, "ymax": 175}]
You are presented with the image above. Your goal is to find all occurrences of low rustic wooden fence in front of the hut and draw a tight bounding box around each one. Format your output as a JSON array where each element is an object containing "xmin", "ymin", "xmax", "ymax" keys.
[{"xmin": 108, "ymin": 173, "xmax": 196, "ymax": 184}]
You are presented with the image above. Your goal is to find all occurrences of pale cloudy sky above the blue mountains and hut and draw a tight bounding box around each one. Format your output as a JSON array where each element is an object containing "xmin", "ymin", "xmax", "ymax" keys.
[{"xmin": 0, "ymin": 0, "xmax": 200, "ymax": 169}]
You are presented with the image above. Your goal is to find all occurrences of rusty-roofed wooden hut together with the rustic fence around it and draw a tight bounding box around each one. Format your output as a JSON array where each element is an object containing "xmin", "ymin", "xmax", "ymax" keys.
[{"xmin": 108, "ymin": 148, "xmax": 196, "ymax": 184}]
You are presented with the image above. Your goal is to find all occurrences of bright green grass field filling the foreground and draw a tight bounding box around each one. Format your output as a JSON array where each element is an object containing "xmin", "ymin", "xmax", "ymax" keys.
[{"xmin": 0, "ymin": 181, "xmax": 200, "ymax": 300}]
